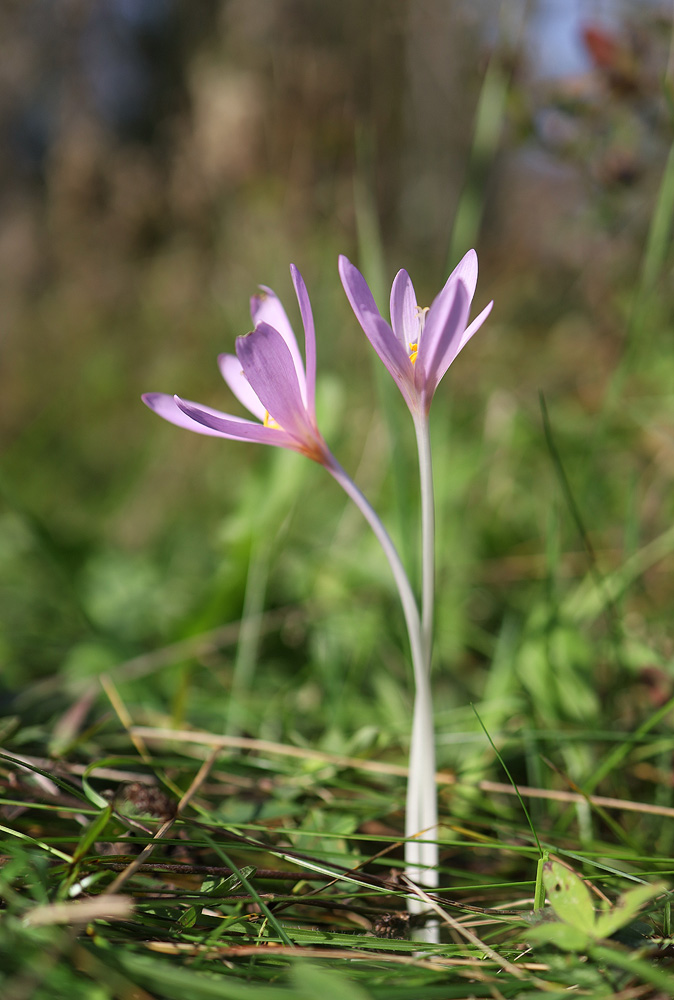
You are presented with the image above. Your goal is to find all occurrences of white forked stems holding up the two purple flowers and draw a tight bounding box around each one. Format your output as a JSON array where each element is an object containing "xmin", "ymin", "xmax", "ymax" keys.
[{"xmin": 325, "ymin": 450, "xmax": 438, "ymax": 942}]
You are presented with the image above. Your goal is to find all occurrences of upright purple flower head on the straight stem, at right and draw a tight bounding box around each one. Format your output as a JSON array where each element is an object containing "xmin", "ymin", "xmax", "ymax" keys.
[{"xmin": 339, "ymin": 250, "xmax": 493, "ymax": 416}]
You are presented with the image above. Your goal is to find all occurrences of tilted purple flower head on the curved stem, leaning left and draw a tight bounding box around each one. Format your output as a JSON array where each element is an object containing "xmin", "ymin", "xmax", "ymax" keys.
[{"xmin": 142, "ymin": 265, "xmax": 330, "ymax": 465}]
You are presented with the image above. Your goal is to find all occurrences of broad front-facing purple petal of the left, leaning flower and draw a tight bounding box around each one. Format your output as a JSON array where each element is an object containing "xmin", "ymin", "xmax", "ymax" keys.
[{"xmin": 236, "ymin": 323, "xmax": 310, "ymax": 440}]
